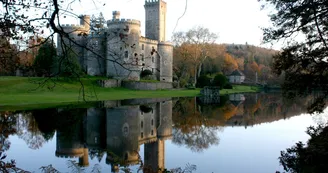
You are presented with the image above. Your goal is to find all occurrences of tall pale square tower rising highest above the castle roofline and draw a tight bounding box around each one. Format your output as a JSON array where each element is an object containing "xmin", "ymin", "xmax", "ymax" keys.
[{"xmin": 145, "ymin": 0, "xmax": 166, "ymax": 41}]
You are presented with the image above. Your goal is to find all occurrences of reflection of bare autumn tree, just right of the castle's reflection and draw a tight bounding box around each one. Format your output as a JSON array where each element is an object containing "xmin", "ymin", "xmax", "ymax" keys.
[{"xmin": 172, "ymin": 98, "xmax": 223, "ymax": 152}]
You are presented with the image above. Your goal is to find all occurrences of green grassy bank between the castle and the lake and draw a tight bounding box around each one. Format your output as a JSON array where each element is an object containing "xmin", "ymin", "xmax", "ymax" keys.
[{"xmin": 0, "ymin": 77, "xmax": 257, "ymax": 109}]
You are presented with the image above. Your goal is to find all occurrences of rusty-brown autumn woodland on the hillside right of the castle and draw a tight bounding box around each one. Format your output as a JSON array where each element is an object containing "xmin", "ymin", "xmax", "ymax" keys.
[{"xmin": 173, "ymin": 43, "xmax": 283, "ymax": 87}]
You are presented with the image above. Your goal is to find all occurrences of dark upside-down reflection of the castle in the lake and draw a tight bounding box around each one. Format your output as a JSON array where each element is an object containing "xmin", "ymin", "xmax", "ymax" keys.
[{"xmin": 56, "ymin": 99, "xmax": 172, "ymax": 172}]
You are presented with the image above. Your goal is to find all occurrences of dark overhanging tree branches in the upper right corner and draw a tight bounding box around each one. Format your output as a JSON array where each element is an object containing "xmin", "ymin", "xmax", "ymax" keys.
[{"xmin": 259, "ymin": 0, "xmax": 328, "ymax": 111}]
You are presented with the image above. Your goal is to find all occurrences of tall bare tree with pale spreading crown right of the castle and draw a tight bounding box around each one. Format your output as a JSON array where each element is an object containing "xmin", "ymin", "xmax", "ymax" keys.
[{"xmin": 173, "ymin": 26, "xmax": 218, "ymax": 85}]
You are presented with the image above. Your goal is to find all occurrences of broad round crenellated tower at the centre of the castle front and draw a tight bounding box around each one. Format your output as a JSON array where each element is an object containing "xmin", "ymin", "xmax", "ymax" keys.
[{"xmin": 106, "ymin": 16, "xmax": 142, "ymax": 80}]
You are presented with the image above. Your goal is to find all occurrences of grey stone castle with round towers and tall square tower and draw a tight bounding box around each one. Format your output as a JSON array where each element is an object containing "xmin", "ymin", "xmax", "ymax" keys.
[{"xmin": 58, "ymin": 0, "xmax": 173, "ymax": 82}]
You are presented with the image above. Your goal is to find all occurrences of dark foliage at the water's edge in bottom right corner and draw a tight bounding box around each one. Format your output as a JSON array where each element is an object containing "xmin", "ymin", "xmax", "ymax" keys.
[{"xmin": 279, "ymin": 93, "xmax": 328, "ymax": 173}]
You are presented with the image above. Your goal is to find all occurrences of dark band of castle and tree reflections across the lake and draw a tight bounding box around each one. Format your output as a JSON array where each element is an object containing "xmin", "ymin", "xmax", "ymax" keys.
[{"xmin": 0, "ymin": 93, "xmax": 322, "ymax": 172}]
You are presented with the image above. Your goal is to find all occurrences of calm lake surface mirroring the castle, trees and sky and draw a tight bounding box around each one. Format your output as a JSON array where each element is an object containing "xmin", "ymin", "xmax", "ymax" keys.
[{"xmin": 0, "ymin": 93, "xmax": 328, "ymax": 173}]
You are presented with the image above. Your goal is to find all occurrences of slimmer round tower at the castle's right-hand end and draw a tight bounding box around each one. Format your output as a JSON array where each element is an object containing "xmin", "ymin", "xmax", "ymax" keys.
[{"xmin": 157, "ymin": 42, "xmax": 173, "ymax": 82}]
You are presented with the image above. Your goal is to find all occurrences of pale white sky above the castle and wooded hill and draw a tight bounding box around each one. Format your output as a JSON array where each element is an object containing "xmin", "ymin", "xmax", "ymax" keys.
[{"xmin": 62, "ymin": 0, "xmax": 279, "ymax": 48}]
